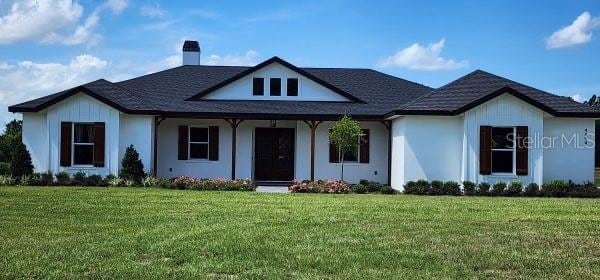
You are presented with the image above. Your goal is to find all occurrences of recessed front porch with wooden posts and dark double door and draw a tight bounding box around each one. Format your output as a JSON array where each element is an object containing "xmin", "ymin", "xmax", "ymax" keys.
[{"xmin": 152, "ymin": 117, "xmax": 390, "ymax": 184}]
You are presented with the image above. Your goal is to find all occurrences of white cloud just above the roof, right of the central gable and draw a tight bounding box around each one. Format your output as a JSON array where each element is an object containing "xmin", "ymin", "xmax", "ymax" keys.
[{"xmin": 379, "ymin": 39, "xmax": 469, "ymax": 71}]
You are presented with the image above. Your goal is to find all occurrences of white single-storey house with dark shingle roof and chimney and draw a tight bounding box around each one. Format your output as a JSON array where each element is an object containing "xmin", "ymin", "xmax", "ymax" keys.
[{"xmin": 9, "ymin": 41, "xmax": 600, "ymax": 189}]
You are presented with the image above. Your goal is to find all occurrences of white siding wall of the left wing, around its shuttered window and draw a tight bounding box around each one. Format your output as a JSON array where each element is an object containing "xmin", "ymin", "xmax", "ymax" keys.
[{"xmin": 23, "ymin": 93, "xmax": 153, "ymax": 176}]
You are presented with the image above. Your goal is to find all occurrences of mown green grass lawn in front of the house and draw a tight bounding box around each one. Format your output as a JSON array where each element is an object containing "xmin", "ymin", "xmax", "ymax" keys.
[{"xmin": 0, "ymin": 187, "xmax": 600, "ymax": 279}]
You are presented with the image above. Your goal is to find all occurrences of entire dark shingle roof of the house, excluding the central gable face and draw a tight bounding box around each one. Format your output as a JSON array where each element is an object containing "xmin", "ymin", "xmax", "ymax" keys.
[{"xmin": 9, "ymin": 58, "xmax": 600, "ymax": 119}]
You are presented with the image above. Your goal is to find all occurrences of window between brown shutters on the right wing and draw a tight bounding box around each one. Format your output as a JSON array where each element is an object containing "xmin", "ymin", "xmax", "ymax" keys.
[{"xmin": 492, "ymin": 127, "xmax": 516, "ymax": 173}]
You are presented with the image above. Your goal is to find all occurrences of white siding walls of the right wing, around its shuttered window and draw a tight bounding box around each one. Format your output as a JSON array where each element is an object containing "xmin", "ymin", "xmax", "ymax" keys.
[{"xmin": 392, "ymin": 94, "xmax": 595, "ymax": 190}]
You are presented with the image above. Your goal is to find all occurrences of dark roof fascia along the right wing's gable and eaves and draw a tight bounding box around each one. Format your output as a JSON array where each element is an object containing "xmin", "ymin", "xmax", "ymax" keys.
[{"xmin": 384, "ymin": 86, "xmax": 600, "ymax": 119}]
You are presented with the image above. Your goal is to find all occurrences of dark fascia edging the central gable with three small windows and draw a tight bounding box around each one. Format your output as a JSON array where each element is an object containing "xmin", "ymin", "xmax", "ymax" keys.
[{"xmin": 186, "ymin": 56, "xmax": 365, "ymax": 103}]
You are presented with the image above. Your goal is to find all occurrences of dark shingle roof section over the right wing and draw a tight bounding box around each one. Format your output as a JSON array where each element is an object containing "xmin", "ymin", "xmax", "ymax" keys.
[{"xmin": 396, "ymin": 70, "xmax": 600, "ymax": 116}]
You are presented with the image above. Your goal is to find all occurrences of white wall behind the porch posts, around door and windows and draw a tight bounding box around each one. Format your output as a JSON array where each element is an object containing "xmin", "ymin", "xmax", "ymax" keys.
[{"xmin": 158, "ymin": 119, "xmax": 388, "ymax": 183}]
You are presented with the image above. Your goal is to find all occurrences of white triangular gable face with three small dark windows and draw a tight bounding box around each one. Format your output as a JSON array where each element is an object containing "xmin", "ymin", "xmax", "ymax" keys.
[{"xmin": 203, "ymin": 63, "xmax": 349, "ymax": 101}]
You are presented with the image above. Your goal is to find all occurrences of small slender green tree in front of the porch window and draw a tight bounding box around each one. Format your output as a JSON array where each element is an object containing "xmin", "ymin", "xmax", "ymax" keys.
[{"xmin": 329, "ymin": 116, "xmax": 362, "ymax": 181}]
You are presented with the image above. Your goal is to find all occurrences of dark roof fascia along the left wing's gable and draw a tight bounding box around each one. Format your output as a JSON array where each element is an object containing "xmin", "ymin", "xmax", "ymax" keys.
[{"xmin": 8, "ymin": 85, "xmax": 159, "ymax": 114}]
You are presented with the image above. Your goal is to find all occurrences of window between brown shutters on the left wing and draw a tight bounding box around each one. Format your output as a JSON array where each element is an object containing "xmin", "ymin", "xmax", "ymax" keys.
[{"xmin": 73, "ymin": 123, "xmax": 94, "ymax": 165}]
